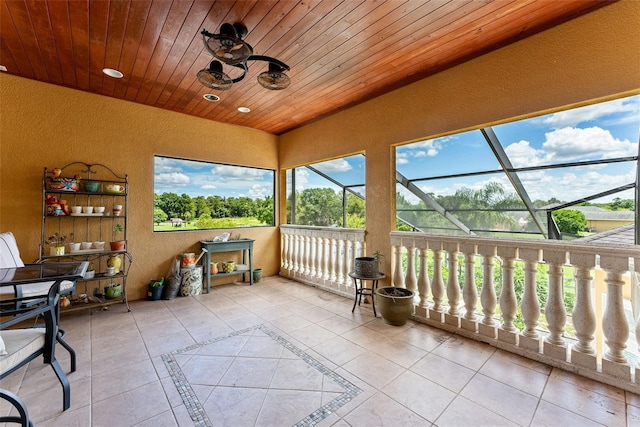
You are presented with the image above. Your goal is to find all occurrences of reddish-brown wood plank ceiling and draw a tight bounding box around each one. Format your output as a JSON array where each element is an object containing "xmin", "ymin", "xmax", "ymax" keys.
[{"xmin": 0, "ymin": 0, "xmax": 611, "ymax": 135}]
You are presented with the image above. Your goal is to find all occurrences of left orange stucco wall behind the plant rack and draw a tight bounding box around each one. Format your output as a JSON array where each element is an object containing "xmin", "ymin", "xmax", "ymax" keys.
[{"xmin": 0, "ymin": 74, "xmax": 280, "ymax": 300}]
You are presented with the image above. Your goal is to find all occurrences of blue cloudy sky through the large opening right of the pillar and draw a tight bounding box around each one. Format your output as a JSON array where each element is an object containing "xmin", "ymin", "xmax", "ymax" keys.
[{"xmin": 396, "ymin": 96, "xmax": 640, "ymax": 206}]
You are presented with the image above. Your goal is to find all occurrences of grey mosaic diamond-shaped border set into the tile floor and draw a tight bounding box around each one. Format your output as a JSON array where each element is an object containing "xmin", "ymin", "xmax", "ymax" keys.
[{"xmin": 162, "ymin": 325, "xmax": 362, "ymax": 427}]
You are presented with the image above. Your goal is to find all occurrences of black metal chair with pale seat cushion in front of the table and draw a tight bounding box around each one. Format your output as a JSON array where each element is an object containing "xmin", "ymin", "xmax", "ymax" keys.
[{"xmin": 0, "ymin": 281, "xmax": 71, "ymax": 412}]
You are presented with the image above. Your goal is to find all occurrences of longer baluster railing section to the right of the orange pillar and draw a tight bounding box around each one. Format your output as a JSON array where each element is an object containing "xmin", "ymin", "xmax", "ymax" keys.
[{"xmin": 390, "ymin": 232, "xmax": 640, "ymax": 393}]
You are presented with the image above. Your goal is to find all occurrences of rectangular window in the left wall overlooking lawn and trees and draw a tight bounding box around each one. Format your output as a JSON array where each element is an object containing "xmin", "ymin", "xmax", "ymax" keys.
[{"xmin": 153, "ymin": 156, "xmax": 275, "ymax": 231}]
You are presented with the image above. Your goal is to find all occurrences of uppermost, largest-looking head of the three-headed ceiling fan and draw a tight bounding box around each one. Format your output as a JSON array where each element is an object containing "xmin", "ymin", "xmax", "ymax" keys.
[{"xmin": 204, "ymin": 23, "xmax": 253, "ymax": 65}]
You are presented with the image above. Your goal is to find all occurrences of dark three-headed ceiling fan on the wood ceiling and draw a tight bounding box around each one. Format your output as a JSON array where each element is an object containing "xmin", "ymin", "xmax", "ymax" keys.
[{"xmin": 197, "ymin": 23, "xmax": 291, "ymax": 90}]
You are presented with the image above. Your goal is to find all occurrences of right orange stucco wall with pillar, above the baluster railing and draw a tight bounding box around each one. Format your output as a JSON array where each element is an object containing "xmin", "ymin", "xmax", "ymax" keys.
[{"xmin": 279, "ymin": 1, "xmax": 640, "ymax": 278}]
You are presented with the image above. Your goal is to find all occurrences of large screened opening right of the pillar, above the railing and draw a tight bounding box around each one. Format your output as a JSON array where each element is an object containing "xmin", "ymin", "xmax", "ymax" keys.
[{"xmin": 396, "ymin": 96, "xmax": 640, "ymax": 238}]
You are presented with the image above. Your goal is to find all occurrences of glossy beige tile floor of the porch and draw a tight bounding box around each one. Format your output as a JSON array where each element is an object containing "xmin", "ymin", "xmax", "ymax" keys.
[{"xmin": 2, "ymin": 277, "xmax": 640, "ymax": 427}]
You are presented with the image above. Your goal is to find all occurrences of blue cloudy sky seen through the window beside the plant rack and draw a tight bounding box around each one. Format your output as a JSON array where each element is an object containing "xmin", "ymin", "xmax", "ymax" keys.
[{"xmin": 154, "ymin": 156, "xmax": 274, "ymax": 199}]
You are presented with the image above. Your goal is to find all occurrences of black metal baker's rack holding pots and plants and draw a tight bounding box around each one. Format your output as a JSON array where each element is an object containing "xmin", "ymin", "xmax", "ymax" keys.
[{"xmin": 39, "ymin": 162, "xmax": 133, "ymax": 311}]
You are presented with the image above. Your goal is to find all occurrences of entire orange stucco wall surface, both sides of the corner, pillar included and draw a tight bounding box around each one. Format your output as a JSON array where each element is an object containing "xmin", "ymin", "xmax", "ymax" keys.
[{"xmin": 0, "ymin": 1, "xmax": 640, "ymax": 299}]
